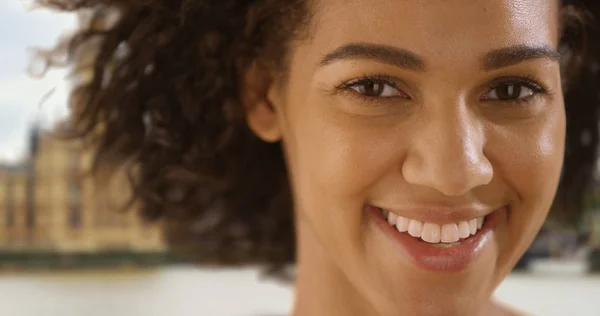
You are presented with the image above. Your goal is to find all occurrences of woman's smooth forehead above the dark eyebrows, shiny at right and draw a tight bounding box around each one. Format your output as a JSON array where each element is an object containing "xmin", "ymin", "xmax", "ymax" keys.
[{"xmin": 311, "ymin": 0, "xmax": 559, "ymax": 64}]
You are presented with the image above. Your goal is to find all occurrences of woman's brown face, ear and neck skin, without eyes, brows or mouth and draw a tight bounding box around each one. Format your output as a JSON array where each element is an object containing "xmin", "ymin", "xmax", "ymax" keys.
[{"xmin": 246, "ymin": 0, "xmax": 565, "ymax": 316}]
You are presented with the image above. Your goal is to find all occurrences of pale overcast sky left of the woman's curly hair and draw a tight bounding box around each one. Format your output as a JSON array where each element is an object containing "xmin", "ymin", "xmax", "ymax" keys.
[{"xmin": 0, "ymin": 0, "xmax": 75, "ymax": 163}]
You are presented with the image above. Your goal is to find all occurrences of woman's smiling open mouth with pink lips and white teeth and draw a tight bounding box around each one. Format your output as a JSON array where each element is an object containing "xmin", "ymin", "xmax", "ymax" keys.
[{"xmin": 365, "ymin": 205, "xmax": 508, "ymax": 272}]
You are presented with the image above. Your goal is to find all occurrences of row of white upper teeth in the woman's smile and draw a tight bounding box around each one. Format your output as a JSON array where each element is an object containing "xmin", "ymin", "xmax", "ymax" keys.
[{"xmin": 381, "ymin": 209, "xmax": 485, "ymax": 247}]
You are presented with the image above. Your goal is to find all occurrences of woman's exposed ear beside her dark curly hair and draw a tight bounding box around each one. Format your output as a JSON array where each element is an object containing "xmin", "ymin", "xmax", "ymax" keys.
[{"xmin": 241, "ymin": 62, "xmax": 281, "ymax": 143}]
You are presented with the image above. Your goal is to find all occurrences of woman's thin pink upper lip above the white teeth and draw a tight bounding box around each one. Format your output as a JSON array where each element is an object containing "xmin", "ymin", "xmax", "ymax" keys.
[{"xmin": 373, "ymin": 205, "xmax": 504, "ymax": 225}]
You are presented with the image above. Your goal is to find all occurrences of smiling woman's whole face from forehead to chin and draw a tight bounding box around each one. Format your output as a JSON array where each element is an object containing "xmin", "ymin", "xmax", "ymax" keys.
[{"xmin": 248, "ymin": 0, "xmax": 565, "ymax": 315}]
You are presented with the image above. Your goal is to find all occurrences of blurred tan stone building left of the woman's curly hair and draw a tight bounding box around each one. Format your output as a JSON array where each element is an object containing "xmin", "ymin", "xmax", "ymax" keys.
[{"xmin": 0, "ymin": 125, "xmax": 165, "ymax": 253}]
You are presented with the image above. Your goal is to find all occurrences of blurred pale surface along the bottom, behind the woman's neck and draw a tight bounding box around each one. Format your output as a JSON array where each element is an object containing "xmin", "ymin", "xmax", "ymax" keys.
[{"xmin": 0, "ymin": 264, "xmax": 600, "ymax": 316}]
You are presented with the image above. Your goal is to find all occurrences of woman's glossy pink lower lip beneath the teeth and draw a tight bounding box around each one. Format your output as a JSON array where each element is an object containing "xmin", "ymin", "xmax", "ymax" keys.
[{"xmin": 366, "ymin": 206, "xmax": 506, "ymax": 272}]
